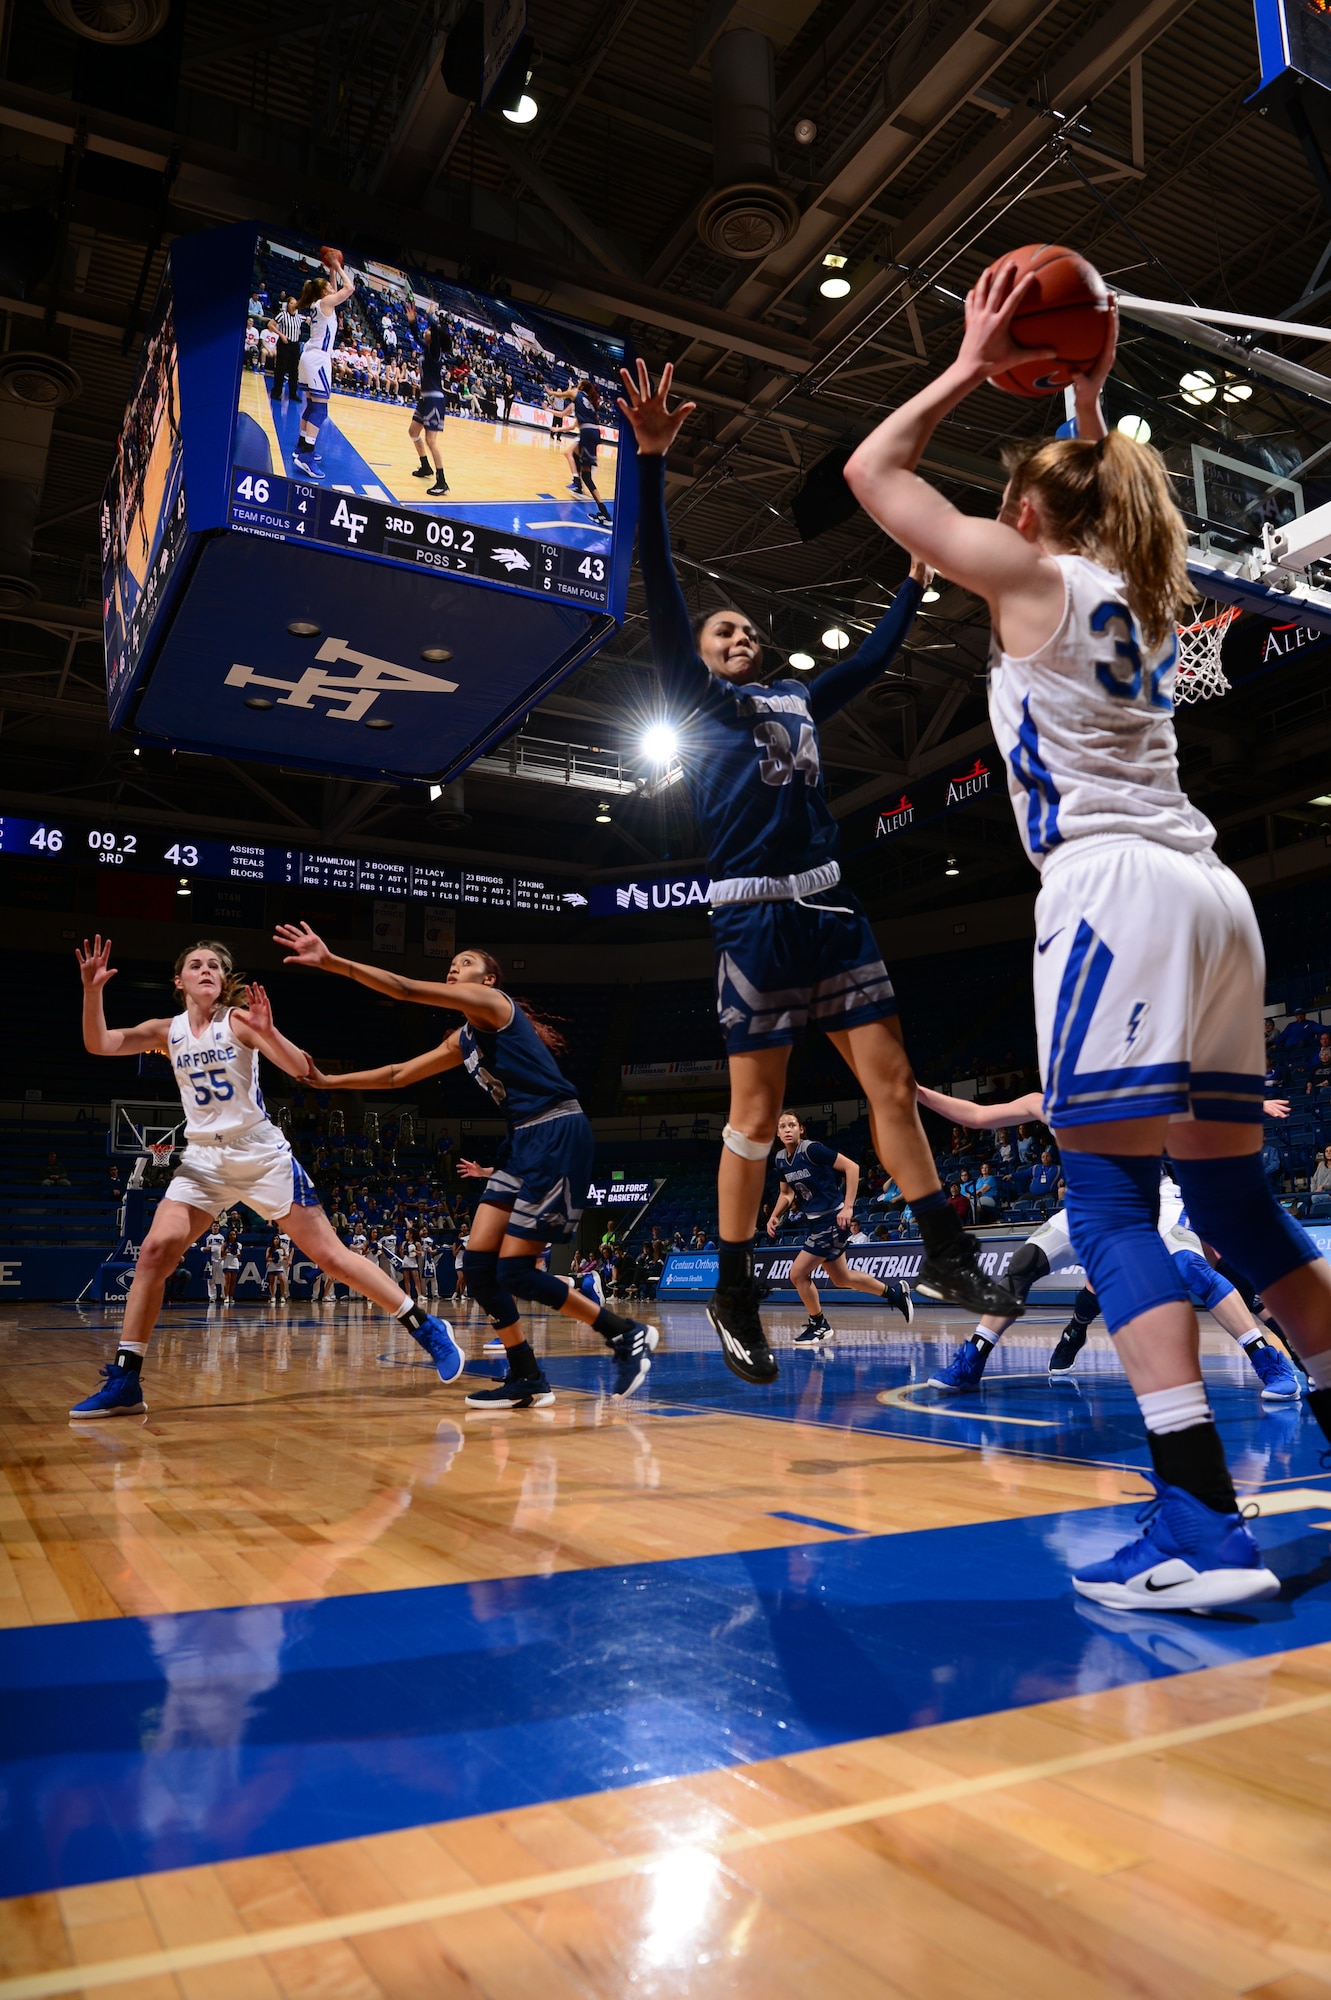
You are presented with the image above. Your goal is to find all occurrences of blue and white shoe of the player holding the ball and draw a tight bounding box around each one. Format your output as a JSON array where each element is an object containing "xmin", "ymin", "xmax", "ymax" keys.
[{"xmin": 1073, "ymin": 1472, "xmax": 1281, "ymax": 1612}]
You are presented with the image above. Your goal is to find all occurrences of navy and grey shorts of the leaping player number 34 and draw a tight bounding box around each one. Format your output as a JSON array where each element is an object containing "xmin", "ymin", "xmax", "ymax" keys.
[{"xmin": 711, "ymin": 882, "xmax": 897, "ymax": 1056}]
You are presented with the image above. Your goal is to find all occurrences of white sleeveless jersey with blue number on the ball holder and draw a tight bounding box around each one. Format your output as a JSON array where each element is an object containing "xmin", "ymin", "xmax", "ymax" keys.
[{"xmin": 989, "ymin": 556, "xmax": 1215, "ymax": 868}]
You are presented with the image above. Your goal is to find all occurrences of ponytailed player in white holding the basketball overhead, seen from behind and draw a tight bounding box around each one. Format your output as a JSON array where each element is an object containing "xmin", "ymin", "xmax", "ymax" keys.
[{"xmin": 845, "ymin": 264, "xmax": 1331, "ymax": 1610}]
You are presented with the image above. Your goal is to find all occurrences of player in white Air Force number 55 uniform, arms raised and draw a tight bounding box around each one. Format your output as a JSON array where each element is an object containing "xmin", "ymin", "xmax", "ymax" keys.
[{"xmin": 70, "ymin": 938, "xmax": 464, "ymax": 1416}]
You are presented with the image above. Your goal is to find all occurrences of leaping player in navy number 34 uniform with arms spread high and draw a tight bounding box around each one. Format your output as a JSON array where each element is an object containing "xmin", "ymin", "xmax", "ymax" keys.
[{"xmin": 620, "ymin": 362, "xmax": 1021, "ymax": 1382}]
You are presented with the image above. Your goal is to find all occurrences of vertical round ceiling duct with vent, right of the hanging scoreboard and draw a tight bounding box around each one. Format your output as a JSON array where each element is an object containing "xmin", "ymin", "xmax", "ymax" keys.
[{"xmin": 697, "ymin": 28, "xmax": 799, "ymax": 262}]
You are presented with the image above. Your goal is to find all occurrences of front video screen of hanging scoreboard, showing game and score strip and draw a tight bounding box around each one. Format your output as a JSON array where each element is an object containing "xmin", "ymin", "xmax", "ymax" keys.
[{"xmin": 230, "ymin": 234, "xmax": 624, "ymax": 608}]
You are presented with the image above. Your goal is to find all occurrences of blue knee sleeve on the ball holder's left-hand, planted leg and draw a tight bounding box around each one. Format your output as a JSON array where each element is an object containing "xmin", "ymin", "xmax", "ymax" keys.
[{"xmin": 1063, "ymin": 1152, "xmax": 1187, "ymax": 1334}]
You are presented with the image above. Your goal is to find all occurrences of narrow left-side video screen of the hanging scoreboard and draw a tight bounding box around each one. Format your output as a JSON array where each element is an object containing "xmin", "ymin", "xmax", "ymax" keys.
[{"xmin": 100, "ymin": 278, "xmax": 186, "ymax": 726}]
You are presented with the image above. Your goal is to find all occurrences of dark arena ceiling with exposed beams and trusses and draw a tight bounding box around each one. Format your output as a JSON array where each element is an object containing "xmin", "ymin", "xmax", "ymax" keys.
[{"xmin": 0, "ymin": 0, "xmax": 1331, "ymax": 928}]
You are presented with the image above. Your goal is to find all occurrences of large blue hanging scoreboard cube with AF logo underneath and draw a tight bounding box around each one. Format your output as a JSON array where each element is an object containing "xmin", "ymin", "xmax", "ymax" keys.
[{"xmin": 102, "ymin": 224, "xmax": 636, "ymax": 782}]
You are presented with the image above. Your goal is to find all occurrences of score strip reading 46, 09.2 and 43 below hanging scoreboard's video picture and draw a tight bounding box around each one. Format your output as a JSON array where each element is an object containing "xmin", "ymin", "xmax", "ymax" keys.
[{"xmin": 232, "ymin": 466, "xmax": 610, "ymax": 608}]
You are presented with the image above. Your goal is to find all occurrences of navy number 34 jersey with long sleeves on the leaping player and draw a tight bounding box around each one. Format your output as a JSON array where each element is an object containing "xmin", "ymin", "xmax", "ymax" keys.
[{"xmin": 638, "ymin": 454, "xmax": 921, "ymax": 880}]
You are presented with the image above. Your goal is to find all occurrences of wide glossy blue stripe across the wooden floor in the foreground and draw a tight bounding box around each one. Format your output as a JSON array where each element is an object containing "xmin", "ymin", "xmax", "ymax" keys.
[{"xmin": 0, "ymin": 1492, "xmax": 1331, "ymax": 1896}]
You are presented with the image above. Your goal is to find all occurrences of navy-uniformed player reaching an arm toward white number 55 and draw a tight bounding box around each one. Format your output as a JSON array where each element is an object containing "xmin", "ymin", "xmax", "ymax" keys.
[{"xmin": 276, "ymin": 924, "xmax": 660, "ymax": 1410}]
